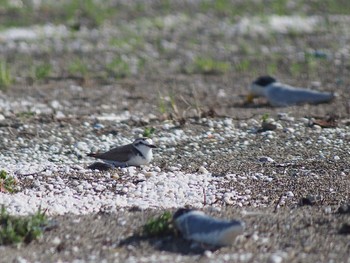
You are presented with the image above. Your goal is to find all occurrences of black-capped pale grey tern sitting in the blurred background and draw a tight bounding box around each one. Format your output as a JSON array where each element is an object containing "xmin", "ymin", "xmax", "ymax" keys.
[{"xmin": 248, "ymin": 76, "xmax": 334, "ymax": 107}]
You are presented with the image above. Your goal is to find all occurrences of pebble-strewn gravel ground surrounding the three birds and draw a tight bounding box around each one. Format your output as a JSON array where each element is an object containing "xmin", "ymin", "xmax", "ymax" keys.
[{"xmin": 0, "ymin": 1, "xmax": 350, "ymax": 263}]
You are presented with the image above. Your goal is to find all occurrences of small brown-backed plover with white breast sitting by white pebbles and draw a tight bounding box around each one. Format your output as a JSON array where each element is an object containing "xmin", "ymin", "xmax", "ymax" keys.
[{"xmin": 88, "ymin": 138, "xmax": 157, "ymax": 167}]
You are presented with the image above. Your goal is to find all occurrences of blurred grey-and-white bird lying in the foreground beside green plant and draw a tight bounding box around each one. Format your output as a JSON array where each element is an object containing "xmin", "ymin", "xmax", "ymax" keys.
[{"xmin": 173, "ymin": 208, "xmax": 245, "ymax": 246}]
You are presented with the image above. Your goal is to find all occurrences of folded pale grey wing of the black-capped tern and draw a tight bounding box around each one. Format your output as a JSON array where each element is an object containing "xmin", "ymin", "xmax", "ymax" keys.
[{"xmin": 267, "ymin": 83, "xmax": 334, "ymax": 106}]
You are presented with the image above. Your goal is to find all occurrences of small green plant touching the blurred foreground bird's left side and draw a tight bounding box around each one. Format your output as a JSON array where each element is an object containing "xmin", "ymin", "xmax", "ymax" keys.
[{"xmin": 142, "ymin": 211, "xmax": 174, "ymax": 237}]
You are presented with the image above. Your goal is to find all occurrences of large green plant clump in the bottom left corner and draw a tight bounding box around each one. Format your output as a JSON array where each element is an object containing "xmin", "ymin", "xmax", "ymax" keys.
[{"xmin": 0, "ymin": 206, "xmax": 48, "ymax": 245}]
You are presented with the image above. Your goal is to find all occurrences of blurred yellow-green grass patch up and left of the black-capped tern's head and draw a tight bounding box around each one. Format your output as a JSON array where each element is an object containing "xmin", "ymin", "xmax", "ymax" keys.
[{"xmin": 186, "ymin": 57, "xmax": 231, "ymax": 74}]
